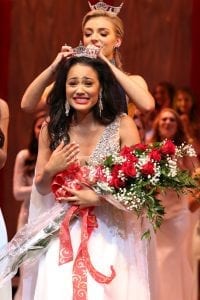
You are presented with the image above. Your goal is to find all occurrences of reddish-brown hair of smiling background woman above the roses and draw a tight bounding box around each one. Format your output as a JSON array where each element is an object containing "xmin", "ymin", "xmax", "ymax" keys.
[{"xmin": 151, "ymin": 108, "xmax": 188, "ymax": 146}]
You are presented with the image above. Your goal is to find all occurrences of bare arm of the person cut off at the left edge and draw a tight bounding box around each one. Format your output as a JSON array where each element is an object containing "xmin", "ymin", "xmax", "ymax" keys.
[{"xmin": 0, "ymin": 99, "xmax": 9, "ymax": 169}]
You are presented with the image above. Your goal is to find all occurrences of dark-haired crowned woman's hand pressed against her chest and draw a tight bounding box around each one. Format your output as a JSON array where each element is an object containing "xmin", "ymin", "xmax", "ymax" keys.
[{"xmin": 46, "ymin": 141, "xmax": 80, "ymax": 175}]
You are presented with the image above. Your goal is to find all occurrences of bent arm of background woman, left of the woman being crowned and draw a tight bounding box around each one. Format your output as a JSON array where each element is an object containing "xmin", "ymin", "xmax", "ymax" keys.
[{"xmin": 13, "ymin": 149, "xmax": 32, "ymax": 200}]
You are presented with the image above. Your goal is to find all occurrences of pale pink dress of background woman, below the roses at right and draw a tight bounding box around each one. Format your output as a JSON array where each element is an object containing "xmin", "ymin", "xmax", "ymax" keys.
[{"xmin": 156, "ymin": 191, "xmax": 194, "ymax": 300}]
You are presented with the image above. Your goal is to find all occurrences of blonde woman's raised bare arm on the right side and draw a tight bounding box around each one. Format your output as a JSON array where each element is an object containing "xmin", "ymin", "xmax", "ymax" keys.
[{"xmin": 99, "ymin": 53, "xmax": 155, "ymax": 112}]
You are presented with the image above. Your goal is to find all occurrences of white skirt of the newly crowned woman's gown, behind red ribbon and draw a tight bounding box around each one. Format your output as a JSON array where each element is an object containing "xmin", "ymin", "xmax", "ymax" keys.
[{"xmin": 33, "ymin": 208, "xmax": 155, "ymax": 300}]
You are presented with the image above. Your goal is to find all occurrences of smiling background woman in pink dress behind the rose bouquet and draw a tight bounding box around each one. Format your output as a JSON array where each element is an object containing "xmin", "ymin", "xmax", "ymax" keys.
[{"xmin": 151, "ymin": 108, "xmax": 198, "ymax": 300}]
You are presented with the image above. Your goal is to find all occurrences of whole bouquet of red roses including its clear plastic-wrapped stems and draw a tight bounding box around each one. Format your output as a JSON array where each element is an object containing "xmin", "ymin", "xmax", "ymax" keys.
[{"xmin": 0, "ymin": 140, "xmax": 199, "ymax": 285}]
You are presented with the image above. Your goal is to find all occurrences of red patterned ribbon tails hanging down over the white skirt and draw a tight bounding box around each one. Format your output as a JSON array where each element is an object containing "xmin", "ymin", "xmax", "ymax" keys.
[{"xmin": 59, "ymin": 206, "xmax": 115, "ymax": 300}]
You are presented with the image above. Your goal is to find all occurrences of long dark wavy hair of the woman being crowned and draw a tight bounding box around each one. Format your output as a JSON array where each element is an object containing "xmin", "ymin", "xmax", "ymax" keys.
[{"xmin": 47, "ymin": 57, "xmax": 123, "ymax": 150}]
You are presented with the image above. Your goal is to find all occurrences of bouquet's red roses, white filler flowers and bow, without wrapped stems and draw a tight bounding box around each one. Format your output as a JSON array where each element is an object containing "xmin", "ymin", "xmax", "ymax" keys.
[{"xmin": 52, "ymin": 140, "xmax": 197, "ymax": 236}]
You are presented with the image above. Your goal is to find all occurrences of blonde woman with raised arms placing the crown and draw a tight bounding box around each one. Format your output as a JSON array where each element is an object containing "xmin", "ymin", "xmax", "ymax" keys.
[{"xmin": 21, "ymin": 9, "xmax": 154, "ymax": 112}]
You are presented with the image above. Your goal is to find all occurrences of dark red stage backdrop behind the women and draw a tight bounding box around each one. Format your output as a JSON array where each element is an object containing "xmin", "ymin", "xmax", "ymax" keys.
[{"xmin": 0, "ymin": 0, "xmax": 200, "ymax": 238}]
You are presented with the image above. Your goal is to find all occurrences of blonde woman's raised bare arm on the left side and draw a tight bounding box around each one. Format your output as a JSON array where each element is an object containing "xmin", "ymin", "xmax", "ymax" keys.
[{"xmin": 21, "ymin": 46, "xmax": 72, "ymax": 112}]
